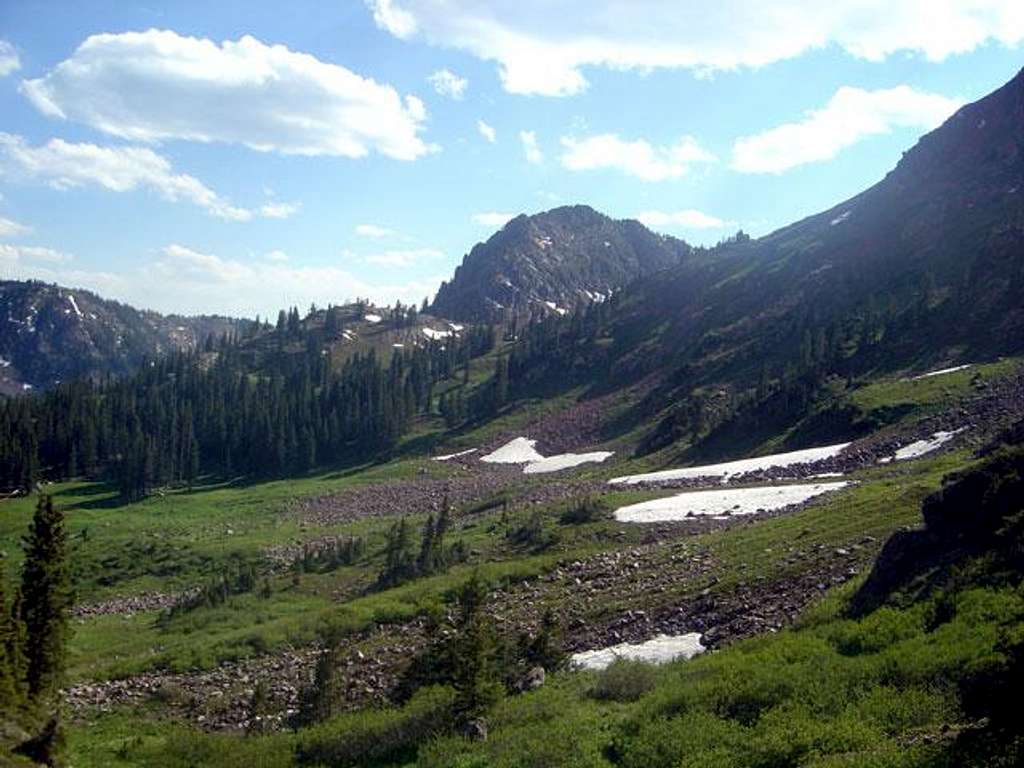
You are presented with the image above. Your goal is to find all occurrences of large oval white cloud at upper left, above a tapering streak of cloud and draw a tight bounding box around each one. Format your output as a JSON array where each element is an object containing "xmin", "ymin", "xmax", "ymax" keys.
[{"xmin": 22, "ymin": 30, "xmax": 434, "ymax": 160}]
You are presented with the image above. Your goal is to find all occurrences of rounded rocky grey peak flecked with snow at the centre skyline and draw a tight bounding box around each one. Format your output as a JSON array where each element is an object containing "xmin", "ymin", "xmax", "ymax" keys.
[{"xmin": 432, "ymin": 206, "xmax": 690, "ymax": 321}]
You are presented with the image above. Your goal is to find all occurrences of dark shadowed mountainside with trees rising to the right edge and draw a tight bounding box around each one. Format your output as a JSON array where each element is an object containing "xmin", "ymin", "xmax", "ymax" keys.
[{"xmin": 503, "ymin": 67, "xmax": 1024, "ymax": 450}]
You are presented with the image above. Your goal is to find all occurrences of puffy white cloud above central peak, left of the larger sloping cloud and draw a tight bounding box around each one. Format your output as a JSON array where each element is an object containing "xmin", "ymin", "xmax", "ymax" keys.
[{"xmin": 561, "ymin": 133, "xmax": 716, "ymax": 181}]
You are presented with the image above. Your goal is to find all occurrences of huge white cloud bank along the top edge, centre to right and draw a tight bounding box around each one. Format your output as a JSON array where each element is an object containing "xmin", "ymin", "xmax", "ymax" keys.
[{"xmin": 367, "ymin": 0, "xmax": 1024, "ymax": 96}]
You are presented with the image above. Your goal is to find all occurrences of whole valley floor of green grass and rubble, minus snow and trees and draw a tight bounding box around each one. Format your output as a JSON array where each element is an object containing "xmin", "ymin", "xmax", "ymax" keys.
[{"xmin": 6, "ymin": 362, "xmax": 1024, "ymax": 766}]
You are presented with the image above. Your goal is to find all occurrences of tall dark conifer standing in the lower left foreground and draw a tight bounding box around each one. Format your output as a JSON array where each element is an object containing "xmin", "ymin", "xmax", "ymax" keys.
[{"xmin": 19, "ymin": 496, "xmax": 73, "ymax": 700}]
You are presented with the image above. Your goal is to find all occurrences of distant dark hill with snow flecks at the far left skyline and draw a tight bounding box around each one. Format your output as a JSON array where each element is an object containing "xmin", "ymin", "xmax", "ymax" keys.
[{"xmin": 0, "ymin": 281, "xmax": 239, "ymax": 394}]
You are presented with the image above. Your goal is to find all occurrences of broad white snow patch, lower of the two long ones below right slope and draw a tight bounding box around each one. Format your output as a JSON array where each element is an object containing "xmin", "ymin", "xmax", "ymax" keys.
[{"xmin": 615, "ymin": 480, "xmax": 849, "ymax": 522}]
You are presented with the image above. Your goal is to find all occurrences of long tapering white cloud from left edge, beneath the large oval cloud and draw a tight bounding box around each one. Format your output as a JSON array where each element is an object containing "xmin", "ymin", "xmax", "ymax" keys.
[{"xmin": 0, "ymin": 133, "xmax": 297, "ymax": 221}]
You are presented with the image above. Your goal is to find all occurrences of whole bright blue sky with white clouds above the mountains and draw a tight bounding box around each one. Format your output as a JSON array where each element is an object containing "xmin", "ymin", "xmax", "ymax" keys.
[{"xmin": 0, "ymin": 0, "xmax": 1024, "ymax": 316}]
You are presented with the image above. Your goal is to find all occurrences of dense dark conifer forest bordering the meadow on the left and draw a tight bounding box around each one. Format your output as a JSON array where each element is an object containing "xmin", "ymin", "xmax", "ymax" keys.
[{"xmin": 0, "ymin": 312, "xmax": 495, "ymax": 500}]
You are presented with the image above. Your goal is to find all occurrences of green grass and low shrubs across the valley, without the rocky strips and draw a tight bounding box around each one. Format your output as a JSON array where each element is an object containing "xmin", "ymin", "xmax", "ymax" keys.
[{"xmin": 0, "ymin": 362, "xmax": 1024, "ymax": 766}]
